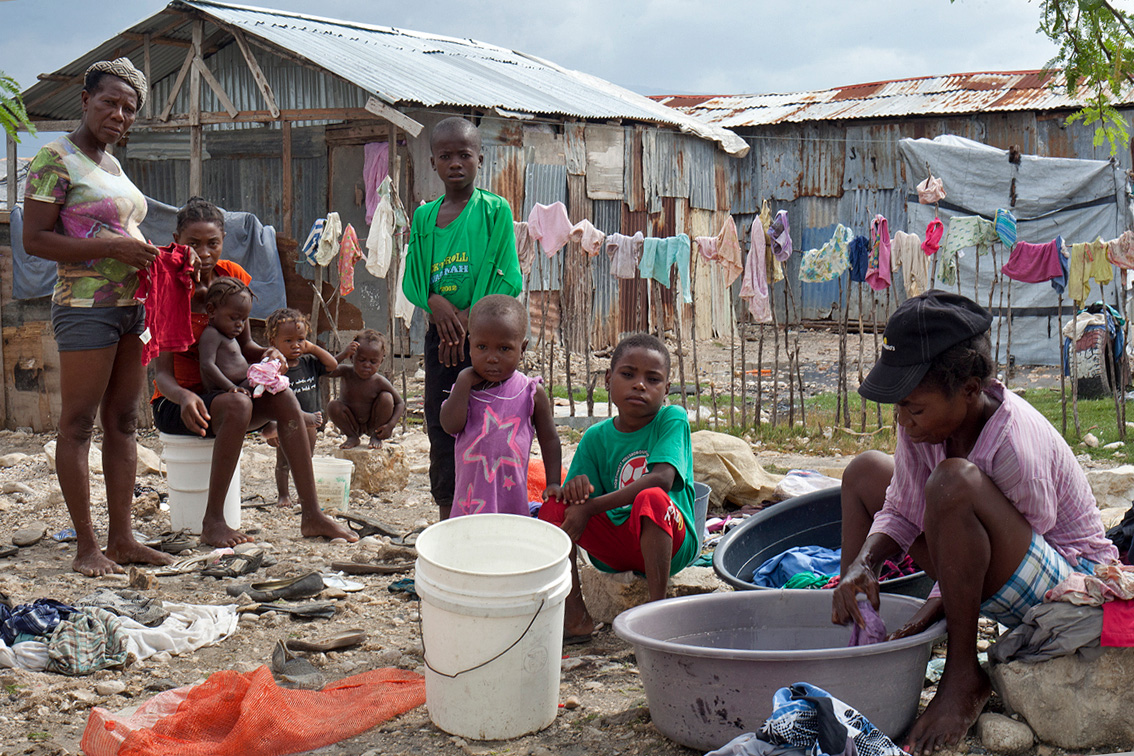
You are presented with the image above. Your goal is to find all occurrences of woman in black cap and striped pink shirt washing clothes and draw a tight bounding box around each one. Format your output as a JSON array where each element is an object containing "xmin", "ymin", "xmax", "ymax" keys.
[{"xmin": 832, "ymin": 290, "xmax": 1118, "ymax": 756}]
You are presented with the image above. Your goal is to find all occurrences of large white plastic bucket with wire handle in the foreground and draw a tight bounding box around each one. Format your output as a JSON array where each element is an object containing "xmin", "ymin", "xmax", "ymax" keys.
[{"xmin": 414, "ymin": 515, "xmax": 570, "ymax": 740}]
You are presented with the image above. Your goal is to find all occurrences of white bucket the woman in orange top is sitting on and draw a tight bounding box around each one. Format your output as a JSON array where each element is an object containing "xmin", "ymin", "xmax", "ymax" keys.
[{"xmin": 159, "ymin": 433, "xmax": 240, "ymax": 534}]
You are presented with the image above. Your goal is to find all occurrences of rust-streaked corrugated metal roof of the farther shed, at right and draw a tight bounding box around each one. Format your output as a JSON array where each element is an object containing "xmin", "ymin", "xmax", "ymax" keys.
[{"xmin": 653, "ymin": 70, "xmax": 1134, "ymax": 128}]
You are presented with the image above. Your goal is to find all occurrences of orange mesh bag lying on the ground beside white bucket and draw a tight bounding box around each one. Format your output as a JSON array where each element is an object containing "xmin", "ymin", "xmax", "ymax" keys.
[{"xmin": 81, "ymin": 666, "xmax": 425, "ymax": 756}]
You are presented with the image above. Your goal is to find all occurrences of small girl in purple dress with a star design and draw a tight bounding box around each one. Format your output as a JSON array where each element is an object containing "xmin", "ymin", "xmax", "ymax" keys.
[{"xmin": 441, "ymin": 295, "xmax": 561, "ymax": 517}]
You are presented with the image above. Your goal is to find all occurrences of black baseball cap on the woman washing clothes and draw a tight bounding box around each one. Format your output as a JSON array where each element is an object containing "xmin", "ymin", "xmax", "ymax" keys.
[{"xmin": 858, "ymin": 289, "xmax": 992, "ymax": 405}]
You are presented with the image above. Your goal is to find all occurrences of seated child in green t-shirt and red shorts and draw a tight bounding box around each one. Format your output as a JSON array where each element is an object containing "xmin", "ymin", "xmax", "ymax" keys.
[{"xmin": 540, "ymin": 333, "xmax": 697, "ymax": 643}]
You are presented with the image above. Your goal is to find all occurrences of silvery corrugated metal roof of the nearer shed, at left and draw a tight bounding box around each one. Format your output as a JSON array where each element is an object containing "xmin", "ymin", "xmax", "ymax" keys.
[{"xmin": 25, "ymin": 0, "xmax": 747, "ymax": 154}]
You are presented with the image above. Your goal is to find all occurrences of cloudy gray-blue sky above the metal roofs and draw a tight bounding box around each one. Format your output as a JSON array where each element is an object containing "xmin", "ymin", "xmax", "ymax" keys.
[{"xmin": 0, "ymin": 0, "xmax": 1055, "ymax": 155}]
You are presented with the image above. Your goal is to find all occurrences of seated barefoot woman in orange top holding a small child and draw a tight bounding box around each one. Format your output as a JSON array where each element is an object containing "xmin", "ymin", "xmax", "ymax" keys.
[{"xmin": 152, "ymin": 197, "xmax": 358, "ymax": 546}]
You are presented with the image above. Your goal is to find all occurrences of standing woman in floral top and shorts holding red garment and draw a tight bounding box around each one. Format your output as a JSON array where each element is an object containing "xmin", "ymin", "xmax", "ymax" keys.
[{"xmin": 24, "ymin": 58, "xmax": 172, "ymax": 576}]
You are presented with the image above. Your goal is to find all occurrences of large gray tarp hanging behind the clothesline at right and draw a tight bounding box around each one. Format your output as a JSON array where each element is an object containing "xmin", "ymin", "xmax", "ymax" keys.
[{"xmin": 891, "ymin": 135, "xmax": 1129, "ymax": 365}]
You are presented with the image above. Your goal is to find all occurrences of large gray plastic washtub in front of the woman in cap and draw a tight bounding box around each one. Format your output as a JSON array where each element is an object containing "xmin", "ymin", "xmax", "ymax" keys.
[{"xmin": 615, "ymin": 589, "xmax": 945, "ymax": 750}]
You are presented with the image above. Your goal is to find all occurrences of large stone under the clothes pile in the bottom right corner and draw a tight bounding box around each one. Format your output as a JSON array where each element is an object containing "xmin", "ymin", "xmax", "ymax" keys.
[{"xmin": 991, "ymin": 648, "xmax": 1134, "ymax": 753}]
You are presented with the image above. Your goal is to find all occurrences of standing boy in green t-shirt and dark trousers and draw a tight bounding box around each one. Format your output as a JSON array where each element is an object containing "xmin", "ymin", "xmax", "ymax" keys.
[{"xmin": 403, "ymin": 118, "xmax": 523, "ymax": 519}]
